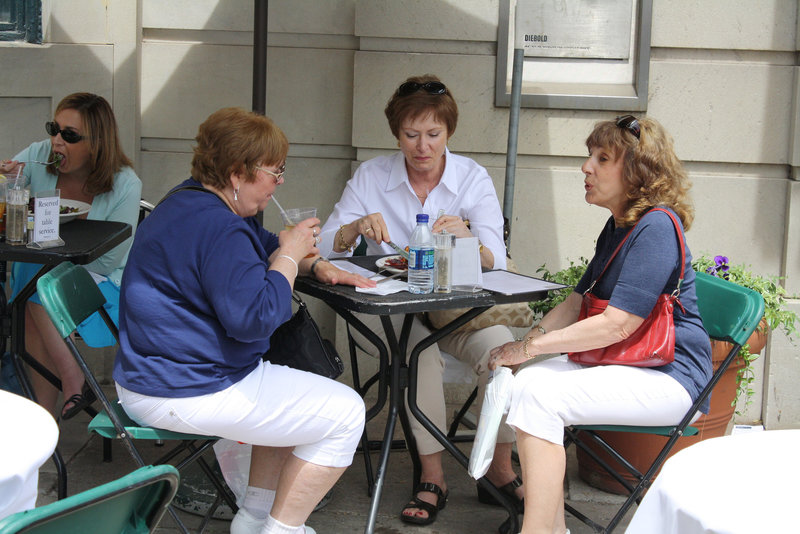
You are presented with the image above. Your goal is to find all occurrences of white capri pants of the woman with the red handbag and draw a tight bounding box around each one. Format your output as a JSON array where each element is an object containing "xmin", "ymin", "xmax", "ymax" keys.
[{"xmin": 507, "ymin": 354, "xmax": 692, "ymax": 445}]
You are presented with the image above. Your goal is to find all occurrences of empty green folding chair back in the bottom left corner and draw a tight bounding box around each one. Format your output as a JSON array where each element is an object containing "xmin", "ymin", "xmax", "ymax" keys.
[{"xmin": 0, "ymin": 465, "xmax": 180, "ymax": 534}]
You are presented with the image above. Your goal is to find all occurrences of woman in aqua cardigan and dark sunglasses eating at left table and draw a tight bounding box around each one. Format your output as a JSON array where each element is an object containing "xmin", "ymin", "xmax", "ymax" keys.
[{"xmin": 0, "ymin": 93, "xmax": 142, "ymax": 419}]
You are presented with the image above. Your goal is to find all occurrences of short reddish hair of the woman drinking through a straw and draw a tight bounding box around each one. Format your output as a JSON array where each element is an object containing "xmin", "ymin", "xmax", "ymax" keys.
[{"xmin": 192, "ymin": 108, "xmax": 289, "ymax": 189}]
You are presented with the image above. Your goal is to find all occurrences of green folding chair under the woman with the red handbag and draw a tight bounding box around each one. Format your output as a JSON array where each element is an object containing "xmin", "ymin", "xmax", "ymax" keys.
[{"xmin": 564, "ymin": 273, "xmax": 764, "ymax": 532}]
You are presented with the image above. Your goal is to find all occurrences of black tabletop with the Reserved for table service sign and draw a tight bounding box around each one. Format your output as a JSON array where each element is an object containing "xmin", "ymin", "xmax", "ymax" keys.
[{"xmin": 0, "ymin": 219, "xmax": 132, "ymax": 265}]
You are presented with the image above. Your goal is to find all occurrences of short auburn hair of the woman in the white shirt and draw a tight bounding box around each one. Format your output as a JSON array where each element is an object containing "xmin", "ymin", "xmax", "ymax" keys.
[{"xmin": 383, "ymin": 74, "xmax": 458, "ymax": 139}]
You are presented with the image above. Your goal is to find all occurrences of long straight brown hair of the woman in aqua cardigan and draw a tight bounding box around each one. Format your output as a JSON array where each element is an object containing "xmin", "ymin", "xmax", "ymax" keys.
[{"xmin": 47, "ymin": 93, "xmax": 133, "ymax": 195}]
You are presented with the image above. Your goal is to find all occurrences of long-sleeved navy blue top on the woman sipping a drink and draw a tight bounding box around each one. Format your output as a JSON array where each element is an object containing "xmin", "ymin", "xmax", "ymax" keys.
[{"xmin": 113, "ymin": 179, "xmax": 292, "ymax": 397}]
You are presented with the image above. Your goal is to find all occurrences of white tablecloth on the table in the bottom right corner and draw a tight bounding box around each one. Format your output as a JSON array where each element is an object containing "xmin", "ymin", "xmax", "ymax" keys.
[{"xmin": 625, "ymin": 430, "xmax": 800, "ymax": 534}]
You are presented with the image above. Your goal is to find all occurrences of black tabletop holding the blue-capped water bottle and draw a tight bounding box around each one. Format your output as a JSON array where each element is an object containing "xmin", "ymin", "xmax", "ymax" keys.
[{"xmin": 295, "ymin": 256, "xmax": 547, "ymax": 315}]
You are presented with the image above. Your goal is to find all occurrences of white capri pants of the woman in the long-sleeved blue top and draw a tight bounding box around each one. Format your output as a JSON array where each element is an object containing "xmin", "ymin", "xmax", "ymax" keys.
[{"xmin": 117, "ymin": 362, "xmax": 364, "ymax": 467}]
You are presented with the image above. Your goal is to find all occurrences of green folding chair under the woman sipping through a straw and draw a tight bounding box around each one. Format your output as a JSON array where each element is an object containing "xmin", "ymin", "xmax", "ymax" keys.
[{"xmin": 36, "ymin": 262, "xmax": 238, "ymax": 532}]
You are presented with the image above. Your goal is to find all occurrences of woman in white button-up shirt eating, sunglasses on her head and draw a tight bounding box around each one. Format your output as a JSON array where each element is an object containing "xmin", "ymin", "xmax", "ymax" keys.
[{"xmin": 320, "ymin": 75, "xmax": 522, "ymax": 525}]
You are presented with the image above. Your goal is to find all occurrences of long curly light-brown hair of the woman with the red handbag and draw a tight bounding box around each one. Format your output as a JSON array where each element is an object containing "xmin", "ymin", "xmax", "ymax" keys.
[{"xmin": 586, "ymin": 118, "xmax": 694, "ymax": 230}]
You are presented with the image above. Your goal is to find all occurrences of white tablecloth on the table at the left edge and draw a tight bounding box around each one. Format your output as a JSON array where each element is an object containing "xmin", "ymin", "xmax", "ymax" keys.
[{"xmin": 0, "ymin": 390, "xmax": 58, "ymax": 518}]
